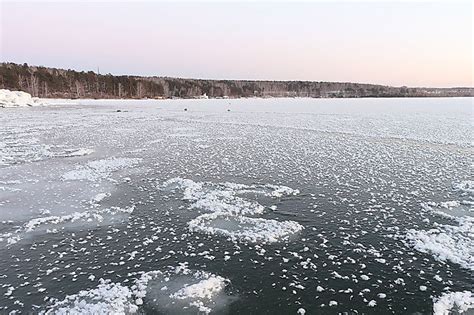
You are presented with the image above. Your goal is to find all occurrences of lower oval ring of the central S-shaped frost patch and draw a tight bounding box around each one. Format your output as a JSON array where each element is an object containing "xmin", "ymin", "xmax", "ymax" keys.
[{"xmin": 188, "ymin": 213, "xmax": 303, "ymax": 243}]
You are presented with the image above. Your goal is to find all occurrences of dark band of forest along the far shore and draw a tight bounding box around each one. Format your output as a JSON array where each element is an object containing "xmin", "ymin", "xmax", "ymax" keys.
[{"xmin": 0, "ymin": 63, "xmax": 473, "ymax": 98}]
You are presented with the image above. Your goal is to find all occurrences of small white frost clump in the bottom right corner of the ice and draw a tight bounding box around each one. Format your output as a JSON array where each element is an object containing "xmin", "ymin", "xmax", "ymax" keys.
[{"xmin": 433, "ymin": 291, "xmax": 474, "ymax": 315}]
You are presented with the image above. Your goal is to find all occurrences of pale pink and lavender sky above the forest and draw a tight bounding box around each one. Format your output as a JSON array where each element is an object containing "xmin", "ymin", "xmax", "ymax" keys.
[{"xmin": 0, "ymin": 0, "xmax": 474, "ymax": 87}]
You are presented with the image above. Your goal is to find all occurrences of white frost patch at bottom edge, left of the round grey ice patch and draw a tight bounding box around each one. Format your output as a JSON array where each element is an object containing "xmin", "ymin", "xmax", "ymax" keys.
[{"xmin": 40, "ymin": 279, "xmax": 138, "ymax": 315}]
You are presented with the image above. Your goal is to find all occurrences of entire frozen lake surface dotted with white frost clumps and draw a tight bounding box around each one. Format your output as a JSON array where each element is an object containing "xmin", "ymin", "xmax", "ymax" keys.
[{"xmin": 0, "ymin": 98, "xmax": 474, "ymax": 314}]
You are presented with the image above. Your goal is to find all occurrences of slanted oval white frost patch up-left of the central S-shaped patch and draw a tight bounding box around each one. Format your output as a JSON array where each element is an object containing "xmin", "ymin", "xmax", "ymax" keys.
[{"xmin": 62, "ymin": 158, "xmax": 141, "ymax": 181}]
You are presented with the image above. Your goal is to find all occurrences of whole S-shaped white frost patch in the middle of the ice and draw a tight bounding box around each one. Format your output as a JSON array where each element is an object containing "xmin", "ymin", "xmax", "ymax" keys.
[{"xmin": 161, "ymin": 177, "xmax": 303, "ymax": 243}]
